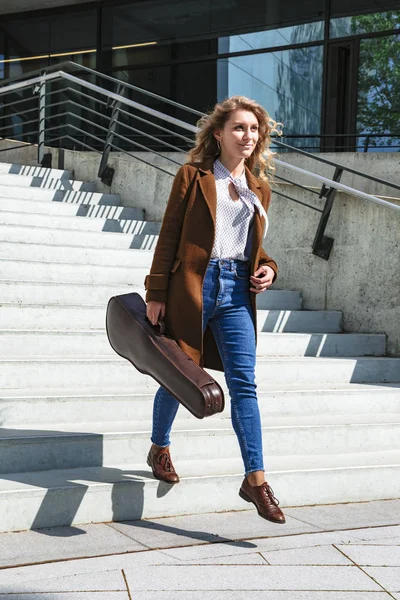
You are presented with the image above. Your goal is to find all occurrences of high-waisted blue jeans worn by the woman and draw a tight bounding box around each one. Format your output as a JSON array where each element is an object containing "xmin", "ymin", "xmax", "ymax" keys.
[{"xmin": 151, "ymin": 259, "xmax": 264, "ymax": 475}]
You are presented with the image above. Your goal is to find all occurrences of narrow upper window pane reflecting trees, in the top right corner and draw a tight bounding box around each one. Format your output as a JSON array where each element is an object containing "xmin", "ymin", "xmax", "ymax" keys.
[{"xmin": 330, "ymin": 10, "xmax": 400, "ymax": 38}]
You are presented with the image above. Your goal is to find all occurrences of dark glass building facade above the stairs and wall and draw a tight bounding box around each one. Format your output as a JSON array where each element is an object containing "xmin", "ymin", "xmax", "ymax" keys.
[{"xmin": 0, "ymin": 0, "xmax": 400, "ymax": 151}]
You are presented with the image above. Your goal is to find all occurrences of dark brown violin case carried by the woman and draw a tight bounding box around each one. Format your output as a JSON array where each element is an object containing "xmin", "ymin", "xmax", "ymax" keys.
[{"xmin": 106, "ymin": 293, "xmax": 225, "ymax": 419}]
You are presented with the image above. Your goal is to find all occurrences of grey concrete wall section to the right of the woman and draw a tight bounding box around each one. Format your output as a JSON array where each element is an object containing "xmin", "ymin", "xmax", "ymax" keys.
[{"xmin": 266, "ymin": 153, "xmax": 400, "ymax": 355}]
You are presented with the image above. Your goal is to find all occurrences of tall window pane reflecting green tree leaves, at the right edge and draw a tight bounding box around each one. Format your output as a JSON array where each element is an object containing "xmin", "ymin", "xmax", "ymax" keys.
[{"xmin": 357, "ymin": 35, "xmax": 400, "ymax": 150}]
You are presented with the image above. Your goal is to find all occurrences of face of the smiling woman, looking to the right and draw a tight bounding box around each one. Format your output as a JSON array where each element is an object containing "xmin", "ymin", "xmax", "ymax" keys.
[{"xmin": 215, "ymin": 109, "xmax": 259, "ymax": 159}]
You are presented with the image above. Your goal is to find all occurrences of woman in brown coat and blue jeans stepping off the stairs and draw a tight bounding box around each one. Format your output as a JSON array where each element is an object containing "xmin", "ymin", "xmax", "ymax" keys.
[{"xmin": 145, "ymin": 96, "xmax": 285, "ymax": 523}]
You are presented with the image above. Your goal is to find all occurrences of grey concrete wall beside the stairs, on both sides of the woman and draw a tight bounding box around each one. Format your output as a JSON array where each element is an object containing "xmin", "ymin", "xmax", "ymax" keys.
[{"xmin": 0, "ymin": 142, "xmax": 400, "ymax": 355}]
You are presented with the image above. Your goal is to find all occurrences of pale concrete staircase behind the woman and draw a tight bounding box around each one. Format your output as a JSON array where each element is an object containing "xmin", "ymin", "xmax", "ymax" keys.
[{"xmin": 0, "ymin": 164, "xmax": 400, "ymax": 531}]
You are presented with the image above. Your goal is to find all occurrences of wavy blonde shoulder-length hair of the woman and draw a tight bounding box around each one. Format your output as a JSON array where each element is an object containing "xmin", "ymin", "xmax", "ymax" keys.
[{"xmin": 188, "ymin": 96, "xmax": 282, "ymax": 181}]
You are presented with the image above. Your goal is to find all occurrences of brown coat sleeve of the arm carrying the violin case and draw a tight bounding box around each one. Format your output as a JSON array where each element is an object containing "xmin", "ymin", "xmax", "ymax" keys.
[{"xmin": 144, "ymin": 165, "xmax": 189, "ymax": 302}]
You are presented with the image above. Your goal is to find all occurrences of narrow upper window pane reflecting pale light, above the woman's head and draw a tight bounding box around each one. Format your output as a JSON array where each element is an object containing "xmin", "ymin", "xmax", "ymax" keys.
[{"xmin": 218, "ymin": 21, "xmax": 324, "ymax": 54}]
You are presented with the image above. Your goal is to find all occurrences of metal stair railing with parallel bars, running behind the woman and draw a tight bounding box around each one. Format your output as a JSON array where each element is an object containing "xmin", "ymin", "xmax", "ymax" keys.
[{"xmin": 0, "ymin": 62, "xmax": 400, "ymax": 260}]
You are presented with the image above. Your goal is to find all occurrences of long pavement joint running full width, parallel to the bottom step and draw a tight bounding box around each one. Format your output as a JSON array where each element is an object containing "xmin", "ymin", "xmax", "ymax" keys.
[{"xmin": 0, "ymin": 515, "xmax": 400, "ymax": 572}]
